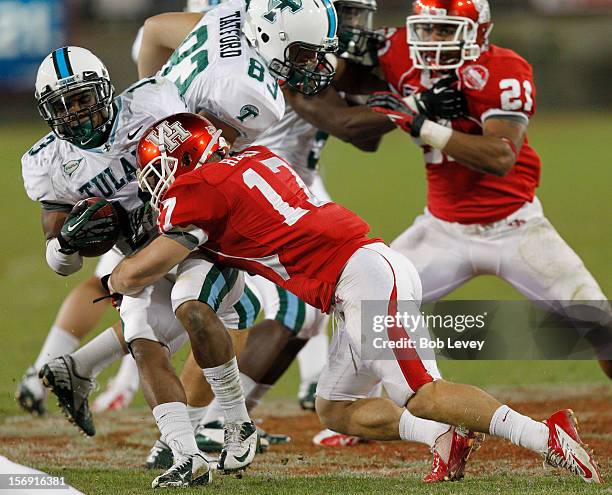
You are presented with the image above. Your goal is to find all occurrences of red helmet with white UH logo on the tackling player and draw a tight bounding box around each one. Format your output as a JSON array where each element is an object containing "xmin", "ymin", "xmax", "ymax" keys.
[{"xmin": 137, "ymin": 113, "xmax": 229, "ymax": 210}]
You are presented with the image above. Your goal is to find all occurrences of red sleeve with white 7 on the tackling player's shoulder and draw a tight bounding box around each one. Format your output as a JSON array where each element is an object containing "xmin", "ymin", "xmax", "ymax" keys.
[{"xmin": 157, "ymin": 179, "xmax": 226, "ymax": 249}]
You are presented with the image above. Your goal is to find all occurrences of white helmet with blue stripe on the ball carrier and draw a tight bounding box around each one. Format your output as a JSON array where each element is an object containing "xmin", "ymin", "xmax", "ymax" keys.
[{"xmin": 35, "ymin": 46, "xmax": 115, "ymax": 148}]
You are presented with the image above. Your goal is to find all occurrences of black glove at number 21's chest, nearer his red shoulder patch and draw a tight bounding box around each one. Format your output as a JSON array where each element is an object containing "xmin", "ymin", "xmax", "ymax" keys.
[{"xmin": 413, "ymin": 75, "xmax": 467, "ymax": 120}]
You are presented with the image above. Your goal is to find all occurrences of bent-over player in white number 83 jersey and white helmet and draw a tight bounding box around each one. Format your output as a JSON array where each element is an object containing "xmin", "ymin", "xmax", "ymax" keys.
[{"xmin": 138, "ymin": 0, "xmax": 337, "ymax": 151}]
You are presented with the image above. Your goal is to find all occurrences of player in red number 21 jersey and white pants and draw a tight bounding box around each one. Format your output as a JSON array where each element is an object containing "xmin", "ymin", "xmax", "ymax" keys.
[{"xmin": 369, "ymin": 0, "xmax": 612, "ymax": 378}]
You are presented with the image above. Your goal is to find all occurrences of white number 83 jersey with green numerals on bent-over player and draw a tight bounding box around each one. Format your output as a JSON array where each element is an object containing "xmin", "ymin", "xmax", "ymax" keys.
[{"xmin": 160, "ymin": 0, "xmax": 285, "ymax": 151}]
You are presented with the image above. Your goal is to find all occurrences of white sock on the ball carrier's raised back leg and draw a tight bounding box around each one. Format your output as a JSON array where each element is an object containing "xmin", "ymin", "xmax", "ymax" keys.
[{"xmin": 72, "ymin": 328, "xmax": 124, "ymax": 378}]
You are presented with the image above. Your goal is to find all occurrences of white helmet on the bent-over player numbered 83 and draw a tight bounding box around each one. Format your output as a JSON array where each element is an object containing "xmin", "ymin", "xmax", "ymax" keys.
[{"xmin": 242, "ymin": 0, "xmax": 338, "ymax": 95}]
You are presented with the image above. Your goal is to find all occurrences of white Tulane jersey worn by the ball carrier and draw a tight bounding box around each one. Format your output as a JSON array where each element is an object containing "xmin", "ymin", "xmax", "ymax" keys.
[{"xmin": 21, "ymin": 78, "xmax": 187, "ymax": 255}]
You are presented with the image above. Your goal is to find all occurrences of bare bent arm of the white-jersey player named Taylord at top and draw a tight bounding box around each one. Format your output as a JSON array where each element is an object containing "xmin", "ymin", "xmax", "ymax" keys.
[{"xmin": 138, "ymin": 12, "xmax": 202, "ymax": 79}]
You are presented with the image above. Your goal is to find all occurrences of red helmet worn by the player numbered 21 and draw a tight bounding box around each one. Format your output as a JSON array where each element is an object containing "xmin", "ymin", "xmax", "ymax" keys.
[{"xmin": 406, "ymin": 0, "xmax": 493, "ymax": 70}]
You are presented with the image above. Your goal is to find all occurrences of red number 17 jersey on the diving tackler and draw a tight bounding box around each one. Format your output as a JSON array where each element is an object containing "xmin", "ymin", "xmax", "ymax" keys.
[{"xmin": 158, "ymin": 146, "xmax": 380, "ymax": 312}]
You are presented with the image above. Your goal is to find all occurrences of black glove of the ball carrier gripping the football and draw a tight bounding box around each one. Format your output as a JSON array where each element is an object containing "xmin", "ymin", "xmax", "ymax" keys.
[{"xmin": 57, "ymin": 201, "xmax": 116, "ymax": 254}]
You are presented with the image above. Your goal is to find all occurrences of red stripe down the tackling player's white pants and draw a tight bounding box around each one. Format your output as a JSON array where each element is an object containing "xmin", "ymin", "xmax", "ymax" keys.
[{"xmin": 381, "ymin": 255, "xmax": 433, "ymax": 392}]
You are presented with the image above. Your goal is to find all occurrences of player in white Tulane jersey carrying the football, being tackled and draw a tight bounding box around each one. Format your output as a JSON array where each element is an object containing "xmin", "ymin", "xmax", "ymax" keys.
[{"xmin": 23, "ymin": 47, "xmax": 257, "ymax": 486}]
